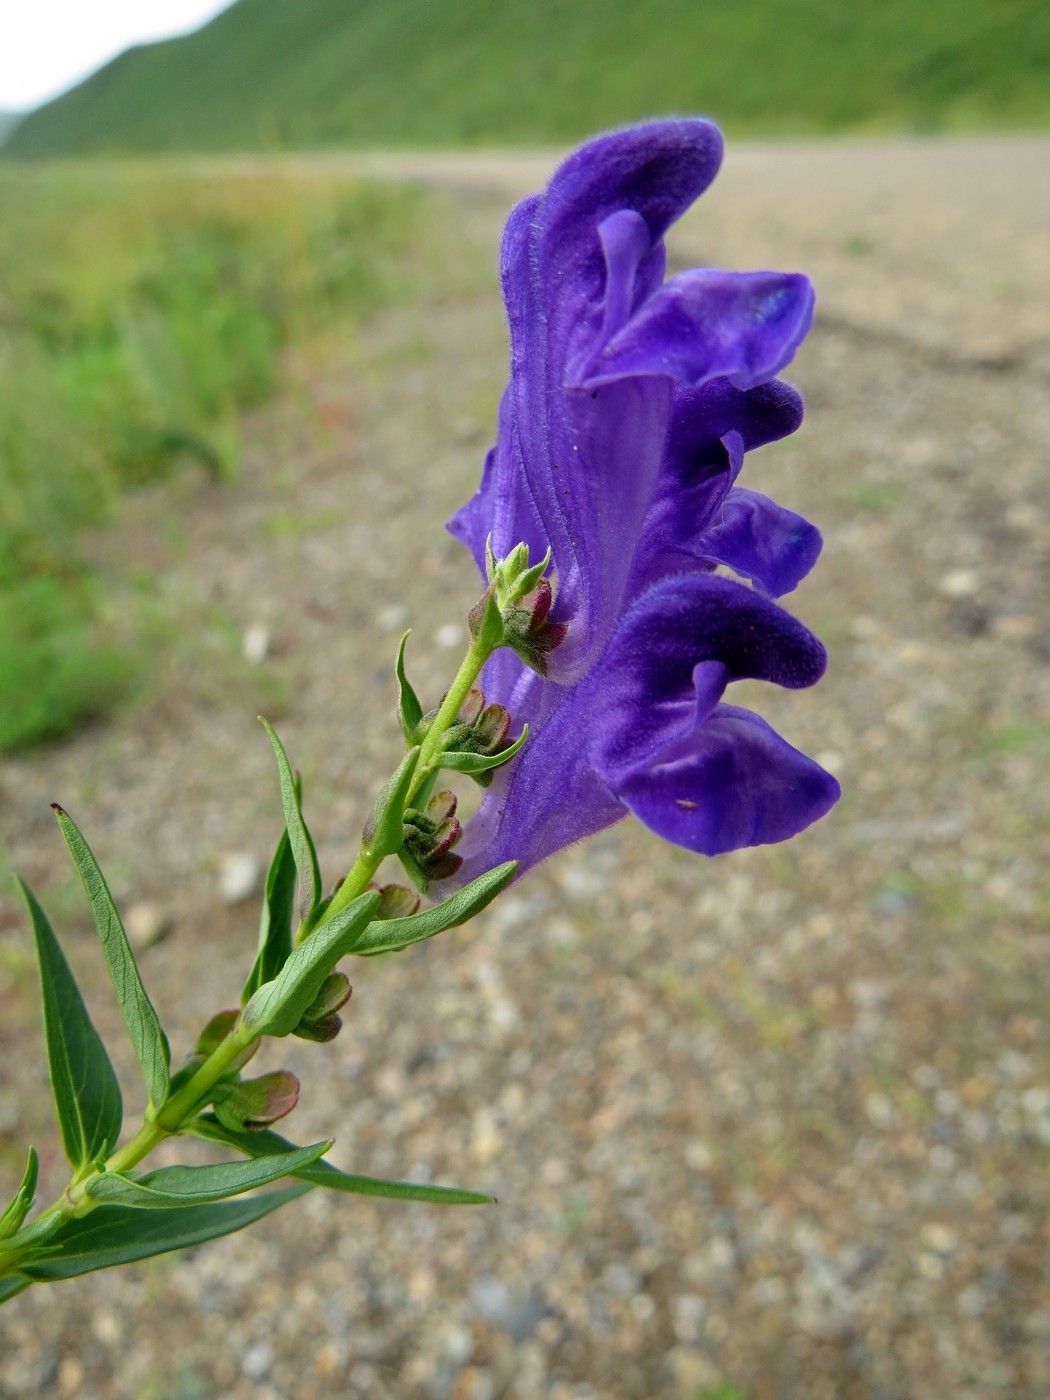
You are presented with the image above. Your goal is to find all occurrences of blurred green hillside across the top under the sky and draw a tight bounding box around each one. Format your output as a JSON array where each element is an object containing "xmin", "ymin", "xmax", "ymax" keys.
[{"xmin": 4, "ymin": 0, "xmax": 1050, "ymax": 157}]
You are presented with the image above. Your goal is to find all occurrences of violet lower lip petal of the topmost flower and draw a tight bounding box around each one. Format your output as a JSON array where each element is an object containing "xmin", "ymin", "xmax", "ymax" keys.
[{"xmin": 580, "ymin": 267, "xmax": 813, "ymax": 389}]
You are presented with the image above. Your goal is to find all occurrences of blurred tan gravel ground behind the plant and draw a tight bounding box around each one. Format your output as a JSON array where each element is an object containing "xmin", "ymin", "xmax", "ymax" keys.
[{"xmin": 0, "ymin": 140, "xmax": 1050, "ymax": 1400}]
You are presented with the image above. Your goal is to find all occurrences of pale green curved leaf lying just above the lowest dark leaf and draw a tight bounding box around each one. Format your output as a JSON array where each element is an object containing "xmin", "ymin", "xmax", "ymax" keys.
[{"xmin": 86, "ymin": 1138, "xmax": 332, "ymax": 1204}]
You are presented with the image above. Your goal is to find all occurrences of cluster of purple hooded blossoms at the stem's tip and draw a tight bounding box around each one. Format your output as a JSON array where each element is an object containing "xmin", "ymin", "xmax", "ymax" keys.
[{"xmin": 449, "ymin": 120, "xmax": 839, "ymax": 879}]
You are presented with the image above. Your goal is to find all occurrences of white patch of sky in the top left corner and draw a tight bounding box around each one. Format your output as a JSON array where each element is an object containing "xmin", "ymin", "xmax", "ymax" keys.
[{"xmin": 0, "ymin": 0, "xmax": 231, "ymax": 111}]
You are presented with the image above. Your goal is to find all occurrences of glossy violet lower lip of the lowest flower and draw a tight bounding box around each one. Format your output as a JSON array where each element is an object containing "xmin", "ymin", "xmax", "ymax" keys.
[{"xmin": 617, "ymin": 704, "xmax": 840, "ymax": 855}]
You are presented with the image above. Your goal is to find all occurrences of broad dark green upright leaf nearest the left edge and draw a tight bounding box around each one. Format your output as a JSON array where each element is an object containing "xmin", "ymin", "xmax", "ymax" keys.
[{"xmin": 18, "ymin": 881, "xmax": 123, "ymax": 1170}]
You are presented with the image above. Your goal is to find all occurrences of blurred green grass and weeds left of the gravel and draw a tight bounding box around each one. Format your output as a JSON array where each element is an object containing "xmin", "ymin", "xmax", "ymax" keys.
[{"xmin": 0, "ymin": 167, "xmax": 419, "ymax": 749}]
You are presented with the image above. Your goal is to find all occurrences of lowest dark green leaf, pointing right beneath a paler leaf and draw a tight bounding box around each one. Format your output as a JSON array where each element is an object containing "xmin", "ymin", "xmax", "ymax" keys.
[{"xmin": 20, "ymin": 1182, "xmax": 311, "ymax": 1281}]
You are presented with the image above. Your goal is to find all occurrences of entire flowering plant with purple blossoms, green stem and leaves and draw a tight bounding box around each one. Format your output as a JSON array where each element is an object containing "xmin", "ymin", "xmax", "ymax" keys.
[{"xmin": 0, "ymin": 120, "xmax": 839, "ymax": 1302}]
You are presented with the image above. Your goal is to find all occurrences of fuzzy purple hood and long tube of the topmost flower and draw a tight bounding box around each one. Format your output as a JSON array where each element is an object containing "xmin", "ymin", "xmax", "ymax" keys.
[{"xmin": 481, "ymin": 120, "xmax": 721, "ymax": 680}]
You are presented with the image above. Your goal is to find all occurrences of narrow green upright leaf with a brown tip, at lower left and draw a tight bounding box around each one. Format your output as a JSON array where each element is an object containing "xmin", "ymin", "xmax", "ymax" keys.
[{"xmin": 55, "ymin": 805, "xmax": 171, "ymax": 1109}]
